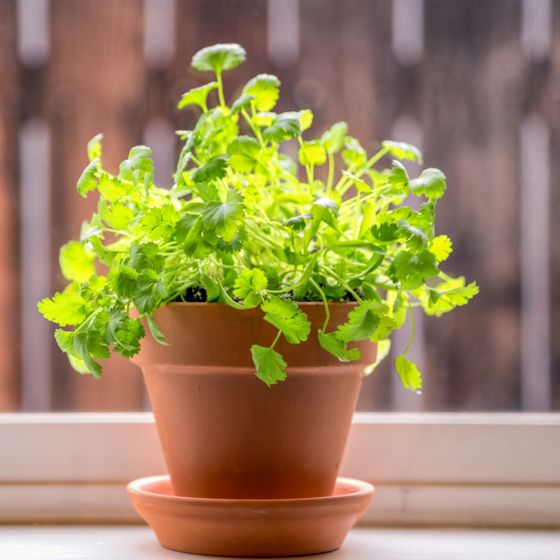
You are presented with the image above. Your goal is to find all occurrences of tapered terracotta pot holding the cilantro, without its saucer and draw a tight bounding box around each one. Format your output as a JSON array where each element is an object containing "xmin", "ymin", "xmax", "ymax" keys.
[{"xmin": 134, "ymin": 303, "xmax": 375, "ymax": 498}]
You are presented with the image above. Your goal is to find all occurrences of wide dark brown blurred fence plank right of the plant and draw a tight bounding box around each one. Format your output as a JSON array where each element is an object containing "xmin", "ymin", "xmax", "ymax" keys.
[{"xmin": 422, "ymin": 0, "xmax": 525, "ymax": 411}]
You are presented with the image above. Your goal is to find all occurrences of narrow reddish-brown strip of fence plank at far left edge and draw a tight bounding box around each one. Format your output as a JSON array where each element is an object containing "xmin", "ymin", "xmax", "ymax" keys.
[{"xmin": 0, "ymin": 0, "xmax": 20, "ymax": 412}]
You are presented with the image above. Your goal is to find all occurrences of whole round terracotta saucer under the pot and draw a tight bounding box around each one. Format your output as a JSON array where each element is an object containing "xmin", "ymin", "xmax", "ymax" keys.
[{"xmin": 128, "ymin": 476, "xmax": 373, "ymax": 556}]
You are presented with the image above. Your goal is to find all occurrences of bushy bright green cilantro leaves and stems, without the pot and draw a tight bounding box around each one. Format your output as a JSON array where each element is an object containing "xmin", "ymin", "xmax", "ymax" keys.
[{"xmin": 39, "ymin": 44, "xmax": 478, "ymax": 390}]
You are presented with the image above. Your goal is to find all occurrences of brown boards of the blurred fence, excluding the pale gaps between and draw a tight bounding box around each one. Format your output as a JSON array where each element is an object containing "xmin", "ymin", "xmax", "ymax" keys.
[{"xmin": 0, "ymin": 0, "xmax": 560, "ymax": 411}]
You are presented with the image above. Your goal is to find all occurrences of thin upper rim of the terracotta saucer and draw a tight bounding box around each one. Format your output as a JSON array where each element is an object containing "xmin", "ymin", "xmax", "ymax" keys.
[{"xmin": 127, "ymin": 475, "xmax": 375, "ymax": 507}]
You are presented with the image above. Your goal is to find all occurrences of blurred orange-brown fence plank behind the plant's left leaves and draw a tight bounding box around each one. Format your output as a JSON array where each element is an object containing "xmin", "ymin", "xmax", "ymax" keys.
[{"xmin": 48, "ymin": 0, "xmax": 145, "ymax": 410}]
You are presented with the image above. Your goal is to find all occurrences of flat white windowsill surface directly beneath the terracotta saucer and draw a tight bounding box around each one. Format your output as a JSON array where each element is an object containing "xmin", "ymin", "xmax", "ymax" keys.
[{"xmin": 0, "ymin": 526, "xmax": 560, "ymax": 560}]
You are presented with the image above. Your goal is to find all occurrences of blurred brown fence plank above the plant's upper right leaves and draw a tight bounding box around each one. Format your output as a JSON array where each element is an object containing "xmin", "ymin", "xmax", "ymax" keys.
[{"xmin": 292, "ymin": 0, "xmax": 391, "ymax": 144}]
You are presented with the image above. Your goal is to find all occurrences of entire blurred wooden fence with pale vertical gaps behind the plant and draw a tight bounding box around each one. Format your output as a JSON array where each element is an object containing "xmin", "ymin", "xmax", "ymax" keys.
[{"xmin": 0, "ymin": 0, "xmax": 560, "ymax": 410}]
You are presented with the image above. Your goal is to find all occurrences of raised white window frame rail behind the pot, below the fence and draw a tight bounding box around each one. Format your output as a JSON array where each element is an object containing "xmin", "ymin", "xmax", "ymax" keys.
[{"xmin": 0, "ymin": 413, "xmax": 560, "ymax": 524}]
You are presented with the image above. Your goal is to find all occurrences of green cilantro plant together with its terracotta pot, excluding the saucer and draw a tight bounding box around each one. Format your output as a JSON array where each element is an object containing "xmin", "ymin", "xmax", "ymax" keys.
[{"xmin": 39, "ymin": 44, "xmax": 478, "ymax": 498}]
